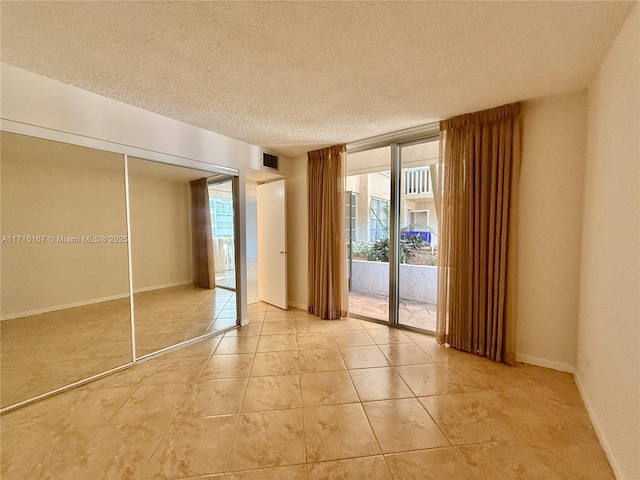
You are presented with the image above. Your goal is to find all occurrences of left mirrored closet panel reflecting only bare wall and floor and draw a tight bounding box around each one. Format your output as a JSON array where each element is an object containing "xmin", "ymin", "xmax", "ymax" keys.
[{"xmin": 0, "ymin": 132, "xmax": 132, "ymax": 407}]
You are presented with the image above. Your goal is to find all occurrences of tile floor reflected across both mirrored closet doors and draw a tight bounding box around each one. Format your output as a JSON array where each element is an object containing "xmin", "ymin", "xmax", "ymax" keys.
[{"xmin": 0, "ymin": 284, "xmax": 236, "ymax": 408}]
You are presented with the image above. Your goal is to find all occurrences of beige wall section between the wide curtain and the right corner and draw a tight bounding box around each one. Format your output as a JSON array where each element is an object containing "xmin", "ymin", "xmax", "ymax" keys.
[{"xmin": 516, "ymin": 91, "xmax": 587, "ymax": 372}]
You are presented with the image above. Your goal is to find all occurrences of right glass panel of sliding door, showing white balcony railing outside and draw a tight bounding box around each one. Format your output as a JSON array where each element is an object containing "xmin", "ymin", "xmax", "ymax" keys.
[{"xmin": 397, "ymin": 141, "xmax": 439, "ymax": 332}]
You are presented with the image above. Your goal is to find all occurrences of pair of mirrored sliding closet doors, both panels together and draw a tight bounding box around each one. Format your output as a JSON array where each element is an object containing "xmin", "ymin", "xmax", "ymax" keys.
[{"xmin": 0, "ymin": 131, "xmax": 239, "ymax": 411}]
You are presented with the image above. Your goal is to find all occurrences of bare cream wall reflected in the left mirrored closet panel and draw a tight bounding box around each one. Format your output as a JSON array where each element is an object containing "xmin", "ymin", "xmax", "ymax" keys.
[{"xmin": 0, "ymin": 132, "xmax": 129, "ymax": 319}]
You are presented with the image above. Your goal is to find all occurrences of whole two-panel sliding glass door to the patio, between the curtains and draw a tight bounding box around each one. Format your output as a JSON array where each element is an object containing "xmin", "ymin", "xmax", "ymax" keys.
[{"xmin": 345, "ymin": 136, "xmax": 438, "ymax": 331}]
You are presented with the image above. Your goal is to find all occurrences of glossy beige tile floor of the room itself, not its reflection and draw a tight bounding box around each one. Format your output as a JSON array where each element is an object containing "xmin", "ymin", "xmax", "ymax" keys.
[{"xmin": 0, "ymin": 303, "xmax": 614, "ymax": 480}]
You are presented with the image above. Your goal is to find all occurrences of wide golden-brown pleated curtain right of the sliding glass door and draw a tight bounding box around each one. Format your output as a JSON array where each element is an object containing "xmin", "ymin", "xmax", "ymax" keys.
[{"xmin": 436, "ymin": 103, "xmax": 521, "ymax": 363}]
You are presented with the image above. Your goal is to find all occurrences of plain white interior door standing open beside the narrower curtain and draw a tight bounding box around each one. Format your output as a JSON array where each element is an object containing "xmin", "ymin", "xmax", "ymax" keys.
[{"xmin": 258, "ymin": 180, "xmax": 289, "ymax": 310}]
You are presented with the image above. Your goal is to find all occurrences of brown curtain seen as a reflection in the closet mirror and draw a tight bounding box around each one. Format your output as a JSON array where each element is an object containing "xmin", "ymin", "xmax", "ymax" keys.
[{"xmin": 190, "ymin": 178, "xmax": 216, "ymax": 288}]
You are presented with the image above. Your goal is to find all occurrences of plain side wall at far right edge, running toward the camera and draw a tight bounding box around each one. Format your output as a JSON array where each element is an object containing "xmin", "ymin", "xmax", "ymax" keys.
[{"xmin": 576, "ymin": 5, "xmax": 640, "ymax": 480}]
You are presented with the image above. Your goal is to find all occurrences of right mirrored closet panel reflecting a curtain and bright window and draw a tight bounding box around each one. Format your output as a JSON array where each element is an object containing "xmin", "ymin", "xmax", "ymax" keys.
[{"xmin": 128, "ymin": 158, "xmax": 237, "ymax": 357}]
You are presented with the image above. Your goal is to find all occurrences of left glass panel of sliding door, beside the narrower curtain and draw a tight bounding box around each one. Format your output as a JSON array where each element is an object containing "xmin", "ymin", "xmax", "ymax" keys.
[{"xmin": 345, "ymin": 147, "xmax": 391, "ymax": 321}]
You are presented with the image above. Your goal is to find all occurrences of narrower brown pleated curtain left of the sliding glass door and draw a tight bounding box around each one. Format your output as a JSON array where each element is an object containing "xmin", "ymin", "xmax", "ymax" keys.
[{"xmin": 307, "ymin": 145, "xmax": 347, "ymax": 319}]
